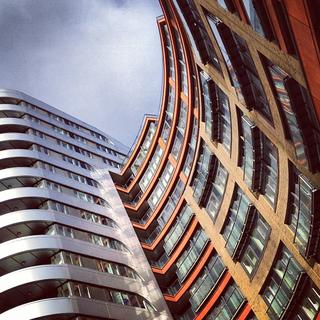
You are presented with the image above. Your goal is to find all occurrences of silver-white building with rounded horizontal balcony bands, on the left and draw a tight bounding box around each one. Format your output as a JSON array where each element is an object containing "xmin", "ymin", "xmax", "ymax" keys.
[{"xmin": 0, "ymin": 90, "xmax": 172, "ymax": 320}]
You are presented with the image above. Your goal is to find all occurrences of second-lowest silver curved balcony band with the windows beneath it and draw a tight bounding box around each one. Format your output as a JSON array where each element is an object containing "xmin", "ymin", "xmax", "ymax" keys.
[{"xmin": 0, "ymin": 265, "xmax": 154, "ymax": 312}]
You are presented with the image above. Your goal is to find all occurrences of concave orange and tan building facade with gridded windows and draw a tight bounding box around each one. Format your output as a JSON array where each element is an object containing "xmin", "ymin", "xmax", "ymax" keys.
[{"xmin": 112, "ymin": 0, "xmax": 320, "ymax": 320}]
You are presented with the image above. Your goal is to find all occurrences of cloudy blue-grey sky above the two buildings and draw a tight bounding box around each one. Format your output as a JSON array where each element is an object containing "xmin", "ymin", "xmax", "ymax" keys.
[{"xmin": 0, "ymin": 0, "xmax": 162, "ymax": 147}]
